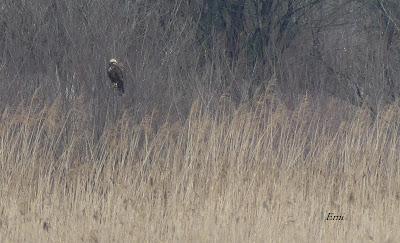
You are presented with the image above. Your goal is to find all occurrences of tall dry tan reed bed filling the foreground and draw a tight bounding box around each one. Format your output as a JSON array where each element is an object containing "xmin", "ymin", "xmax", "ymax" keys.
[{"xmin": 0, "ymin": 97, "xmax": 400, "ymax": 242}]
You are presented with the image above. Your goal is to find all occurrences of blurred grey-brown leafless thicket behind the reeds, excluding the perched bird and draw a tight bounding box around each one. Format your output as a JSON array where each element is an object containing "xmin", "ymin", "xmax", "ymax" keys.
[{"xmin": 0, "ymin": 0, "xmax": 400, "ymax": 125}]
